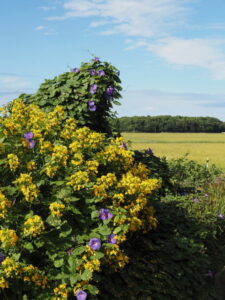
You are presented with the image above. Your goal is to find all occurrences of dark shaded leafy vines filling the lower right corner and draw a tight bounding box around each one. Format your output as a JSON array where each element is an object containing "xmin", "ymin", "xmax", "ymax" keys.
[{"xmin": 99, "ymin": 196, "xmax": 225, "ymax": 300}]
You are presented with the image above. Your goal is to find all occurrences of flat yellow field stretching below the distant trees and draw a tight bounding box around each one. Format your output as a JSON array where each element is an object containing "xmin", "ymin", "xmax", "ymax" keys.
[{"xmin": 122, "ymin": 132, "xmax": 225, "ymax": 169}]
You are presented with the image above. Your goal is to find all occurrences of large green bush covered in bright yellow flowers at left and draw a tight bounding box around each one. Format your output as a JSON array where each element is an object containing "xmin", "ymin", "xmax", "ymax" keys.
[{"xmin": 0, "ymin": 99, "xmax": 160, "ymax": 300}]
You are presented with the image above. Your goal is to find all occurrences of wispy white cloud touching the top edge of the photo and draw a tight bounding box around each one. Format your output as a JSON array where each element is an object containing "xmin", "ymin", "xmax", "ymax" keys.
[{"xmin": 48, "ymin": 0, "xmax": 193, "ymax": 37}]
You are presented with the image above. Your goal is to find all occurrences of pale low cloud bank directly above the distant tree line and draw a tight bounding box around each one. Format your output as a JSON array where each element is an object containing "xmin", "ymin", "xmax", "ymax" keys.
[{"xmin": 114, "ymin": 90, "xmax": 225, "ymax": 121}]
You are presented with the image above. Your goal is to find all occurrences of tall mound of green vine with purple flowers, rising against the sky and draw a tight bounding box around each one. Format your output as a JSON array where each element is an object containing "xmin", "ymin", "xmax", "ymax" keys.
[{"xmin": 20, "ymin": 58, "xmax": 121, "ymax": 133}]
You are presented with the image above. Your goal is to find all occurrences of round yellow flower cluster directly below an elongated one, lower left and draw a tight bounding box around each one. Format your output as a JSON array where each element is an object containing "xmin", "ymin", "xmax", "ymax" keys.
[{"xmin": 23, "ymin": 215, "xmax": 45, "ymax": 237}]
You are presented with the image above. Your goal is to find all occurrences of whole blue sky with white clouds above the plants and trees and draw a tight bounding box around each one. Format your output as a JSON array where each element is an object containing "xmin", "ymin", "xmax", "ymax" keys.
[{"xmin": 0, "ymin": 0, "xmax": 225, "ymax": 121}]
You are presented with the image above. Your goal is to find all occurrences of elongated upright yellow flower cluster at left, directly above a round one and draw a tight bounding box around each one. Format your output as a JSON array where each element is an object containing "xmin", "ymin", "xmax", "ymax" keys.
[{"xmin": 15, "ymin": 173, "xmax": 39, "ymax": 202}]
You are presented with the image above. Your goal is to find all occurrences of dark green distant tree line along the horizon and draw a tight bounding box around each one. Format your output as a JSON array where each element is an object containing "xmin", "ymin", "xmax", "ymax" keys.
[{"xmin": 113, "ymin": 115, "xmax": 225, "ymax": 133}]
